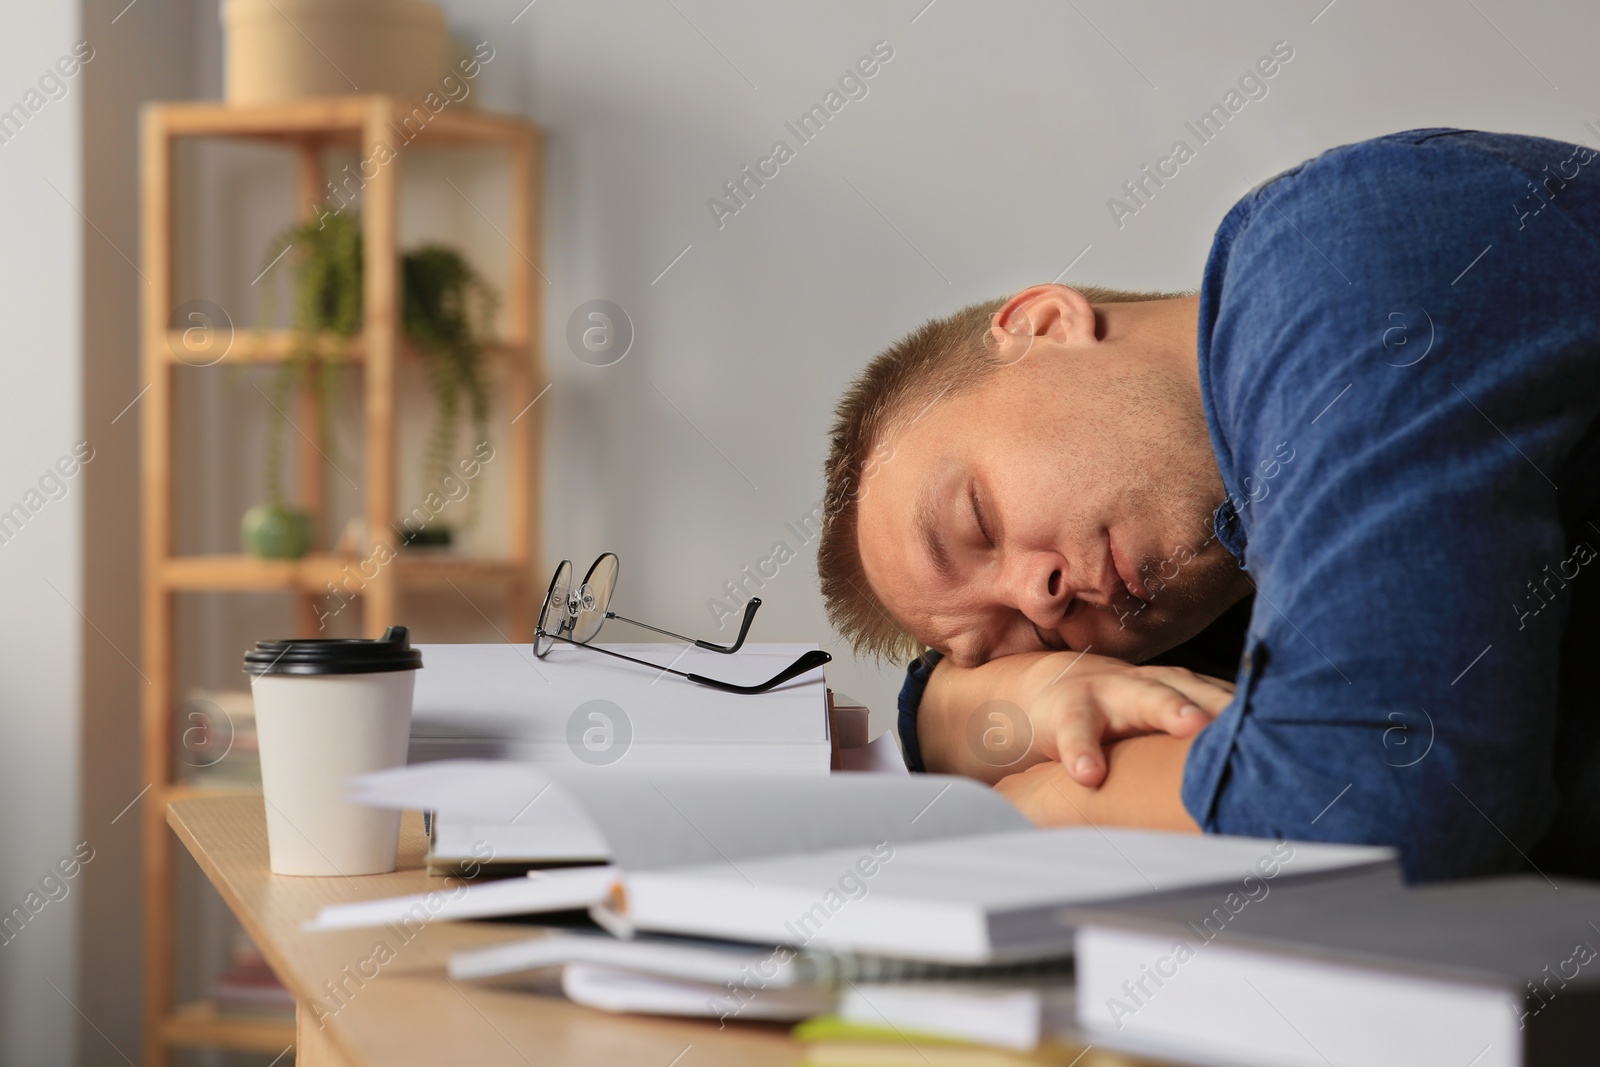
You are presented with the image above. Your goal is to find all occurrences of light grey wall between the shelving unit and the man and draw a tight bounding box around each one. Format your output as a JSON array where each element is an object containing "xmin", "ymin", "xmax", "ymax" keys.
[{"xmin": 445, "ymin": 0, "xmax": 1600, "ymax": 728}]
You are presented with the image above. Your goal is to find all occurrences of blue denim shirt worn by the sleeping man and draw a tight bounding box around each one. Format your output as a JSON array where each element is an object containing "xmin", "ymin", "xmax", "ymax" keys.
[{"xmin": 899, "ymin": 130, "xmax": 1600, "ymax": 878}]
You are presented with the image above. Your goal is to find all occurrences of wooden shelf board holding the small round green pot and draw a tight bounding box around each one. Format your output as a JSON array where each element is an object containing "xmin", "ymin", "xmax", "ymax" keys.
[{"xmin": 160, "ymin": 559, "xmax": 528, "ymax": 593}]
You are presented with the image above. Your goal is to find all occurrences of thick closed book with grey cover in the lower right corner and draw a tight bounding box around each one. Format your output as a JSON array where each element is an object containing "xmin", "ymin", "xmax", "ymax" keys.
[{"xmin": 1072, "ymin": 875, "xmax": 1600, "ymax": 1067}]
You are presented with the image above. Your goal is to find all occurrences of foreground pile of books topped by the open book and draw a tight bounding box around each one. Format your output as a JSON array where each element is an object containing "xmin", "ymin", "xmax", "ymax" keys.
[{"xmin": 302, "ymin": 761, "xmax": 1400, "ymax": 1064}]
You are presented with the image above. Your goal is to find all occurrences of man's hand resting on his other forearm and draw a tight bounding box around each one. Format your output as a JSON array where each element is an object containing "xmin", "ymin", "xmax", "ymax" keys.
[{"xmin": 917, "ymin": 653, "xmax": 1234, "ymax": 787}]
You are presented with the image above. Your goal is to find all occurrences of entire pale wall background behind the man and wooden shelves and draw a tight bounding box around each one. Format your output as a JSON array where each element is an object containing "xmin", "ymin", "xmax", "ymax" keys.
[{"xmin": 0, "ymin": 0, "xmax": 1600, "ymax": 1064}]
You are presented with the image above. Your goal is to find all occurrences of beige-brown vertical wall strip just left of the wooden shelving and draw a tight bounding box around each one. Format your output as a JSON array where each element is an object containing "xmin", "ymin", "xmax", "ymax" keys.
[{"xmin": 77, "ymin": 0, "xmax": 213, "ymax": 1065}]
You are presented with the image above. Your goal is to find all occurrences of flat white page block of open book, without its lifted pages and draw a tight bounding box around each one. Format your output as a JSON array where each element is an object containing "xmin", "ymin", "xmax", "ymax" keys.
[{"xmin": 622, "ymin": 827, "xmax": 1400, "ymax": 963}]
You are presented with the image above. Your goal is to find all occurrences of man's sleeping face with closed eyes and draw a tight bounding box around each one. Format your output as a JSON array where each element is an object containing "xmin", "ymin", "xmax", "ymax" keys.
[{"xmin": 858, "ymin": 300, "xmax": 1248, "ymax": 665}]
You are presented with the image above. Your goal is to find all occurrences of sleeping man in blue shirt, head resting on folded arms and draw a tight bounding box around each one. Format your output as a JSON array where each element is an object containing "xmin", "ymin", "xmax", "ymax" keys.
[{"xmin": 818, "ymin": 130, "xmax": 1600, "ymax": 878}]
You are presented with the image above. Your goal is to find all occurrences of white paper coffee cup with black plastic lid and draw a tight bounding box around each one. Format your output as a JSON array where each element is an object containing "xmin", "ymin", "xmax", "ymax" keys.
[{"xmin": 245, "ymin": 625, "xmax": 422, "ymax": 877}]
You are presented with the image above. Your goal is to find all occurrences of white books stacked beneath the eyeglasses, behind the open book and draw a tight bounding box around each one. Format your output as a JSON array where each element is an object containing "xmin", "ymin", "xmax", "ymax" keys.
[{"xmin": 411, "ymin": 643, "xmax": 832, "ymax": 873}]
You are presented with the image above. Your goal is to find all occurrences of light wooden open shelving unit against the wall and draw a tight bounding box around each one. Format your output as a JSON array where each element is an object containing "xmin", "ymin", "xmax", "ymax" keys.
[{"xmin": 139, "ymin": 94, "xmax": 544, "ymax": 1067}]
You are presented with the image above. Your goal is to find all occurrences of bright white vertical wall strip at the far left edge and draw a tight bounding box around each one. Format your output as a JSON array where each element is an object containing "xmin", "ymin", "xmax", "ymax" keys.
[{"xmin": 0, "ymin": 3, "xmax": 84, "ymax": 1065}]
